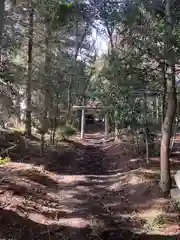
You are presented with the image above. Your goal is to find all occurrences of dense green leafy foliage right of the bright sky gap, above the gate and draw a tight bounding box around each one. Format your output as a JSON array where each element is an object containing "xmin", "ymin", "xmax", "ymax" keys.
[{"xmin": 89, "ymin": 0, "xmax": 180, "ymax": 138}]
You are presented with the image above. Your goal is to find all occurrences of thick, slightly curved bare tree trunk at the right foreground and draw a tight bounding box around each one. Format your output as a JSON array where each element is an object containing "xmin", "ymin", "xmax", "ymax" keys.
[{"xmin": 160, "ymin": 0, "xmax": 177, "ymax": 196}]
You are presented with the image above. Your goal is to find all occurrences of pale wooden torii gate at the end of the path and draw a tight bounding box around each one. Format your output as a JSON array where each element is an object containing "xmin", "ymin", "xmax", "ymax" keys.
[{"xmin": 73, "ymin": 106, "xmax": 109, "ymax": 139}]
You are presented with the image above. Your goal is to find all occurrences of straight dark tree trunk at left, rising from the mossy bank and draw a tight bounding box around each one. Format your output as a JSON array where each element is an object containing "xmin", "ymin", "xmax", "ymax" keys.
[{"xmin": 26, "ymin": 0, "xmax": 34, "ymax": 136}]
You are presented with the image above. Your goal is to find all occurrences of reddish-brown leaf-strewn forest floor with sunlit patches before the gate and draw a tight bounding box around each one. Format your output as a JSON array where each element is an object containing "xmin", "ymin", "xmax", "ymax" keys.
[{"xmin": 0, "ymin": 133, "xmax": 180, "ymax": 240}]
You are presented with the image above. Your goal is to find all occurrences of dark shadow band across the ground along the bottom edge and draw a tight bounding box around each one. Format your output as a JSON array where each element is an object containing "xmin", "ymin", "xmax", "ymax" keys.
[{"xmin": 0, "ymin": 209, "xmax": 178, "ymax": 240}]
